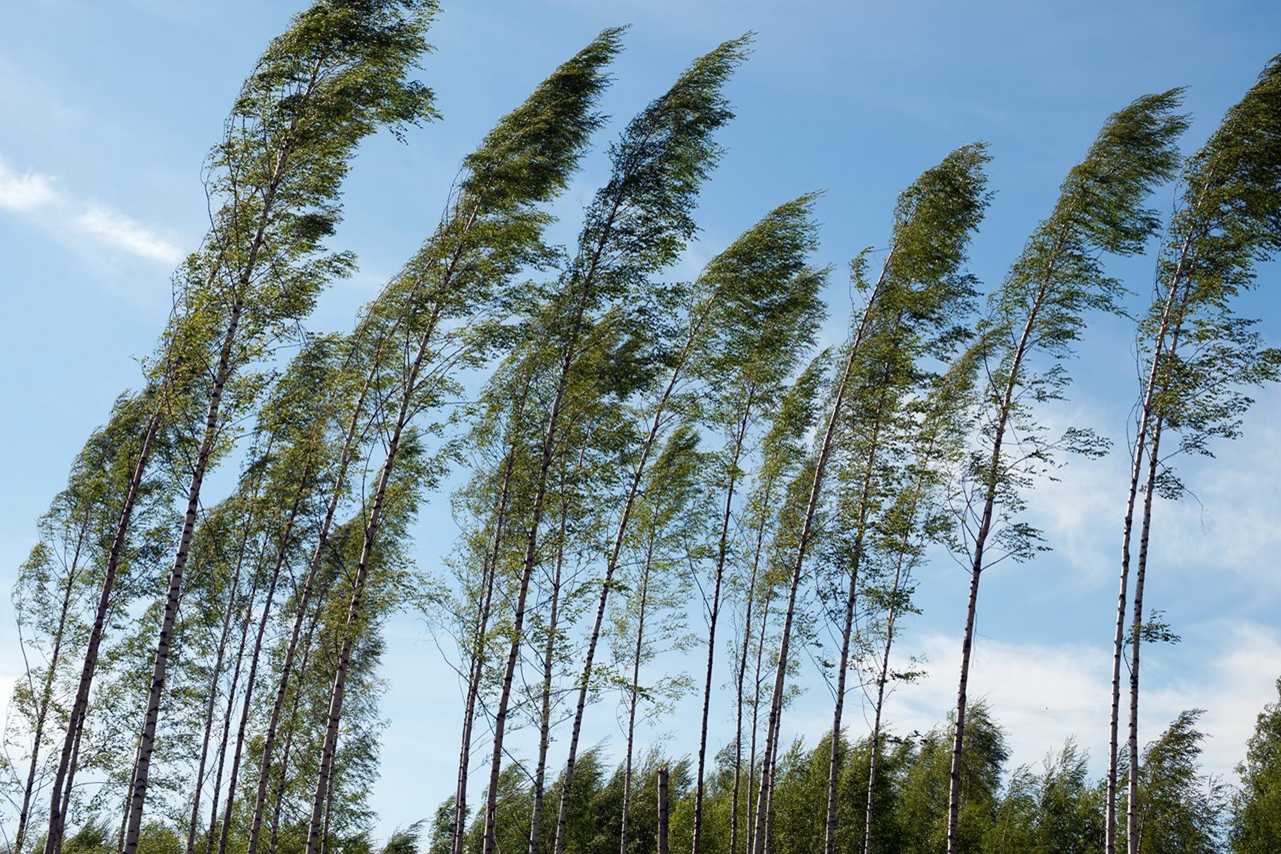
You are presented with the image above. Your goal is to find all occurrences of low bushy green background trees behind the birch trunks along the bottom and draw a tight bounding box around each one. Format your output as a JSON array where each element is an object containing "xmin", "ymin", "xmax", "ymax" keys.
[{"xmin": 428, "ymin": 704, "xmax": 1255, "ymax": 854}]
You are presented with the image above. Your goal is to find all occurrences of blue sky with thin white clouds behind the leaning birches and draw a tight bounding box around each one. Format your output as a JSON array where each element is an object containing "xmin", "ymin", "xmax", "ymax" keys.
[{"xmin": 0, "ymin": 0, "xmax": 1281, "ymax": 831}]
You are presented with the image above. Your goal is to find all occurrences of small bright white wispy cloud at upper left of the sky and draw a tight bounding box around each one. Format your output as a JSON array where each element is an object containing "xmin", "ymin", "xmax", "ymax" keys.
[{"xmin": 0, "ymin": 157, "xmax": 183, "ymax": 266}]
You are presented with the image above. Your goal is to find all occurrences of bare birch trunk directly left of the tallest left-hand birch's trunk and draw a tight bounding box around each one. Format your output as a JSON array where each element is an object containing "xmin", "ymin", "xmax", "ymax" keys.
[{"xmin": 45, "ymin": 403, "xmax": 161, "ymax": 854}]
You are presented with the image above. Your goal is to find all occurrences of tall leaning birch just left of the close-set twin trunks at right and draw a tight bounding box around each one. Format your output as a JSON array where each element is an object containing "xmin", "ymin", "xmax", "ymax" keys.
[{"xmin": 948, "ymin": 91, "xmax": 1186, "ymax": 854}]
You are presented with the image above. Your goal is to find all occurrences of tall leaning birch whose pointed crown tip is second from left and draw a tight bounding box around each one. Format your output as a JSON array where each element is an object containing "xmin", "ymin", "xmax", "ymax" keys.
[{"xmin": 307, "ymin": 29, "xmax": 620, "ymax": 854}]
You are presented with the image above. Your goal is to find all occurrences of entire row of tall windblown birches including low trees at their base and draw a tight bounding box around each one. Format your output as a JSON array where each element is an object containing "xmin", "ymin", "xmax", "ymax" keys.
[{"xmin": 8, "ymin": 0, "xmax": 1281, "ymax": 854}]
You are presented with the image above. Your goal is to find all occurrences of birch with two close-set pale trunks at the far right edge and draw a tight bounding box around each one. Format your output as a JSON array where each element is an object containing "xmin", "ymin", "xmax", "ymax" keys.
[{"xmin": 1107, "ymin": 58, "xmax": 1281, "ymax": 854}]
